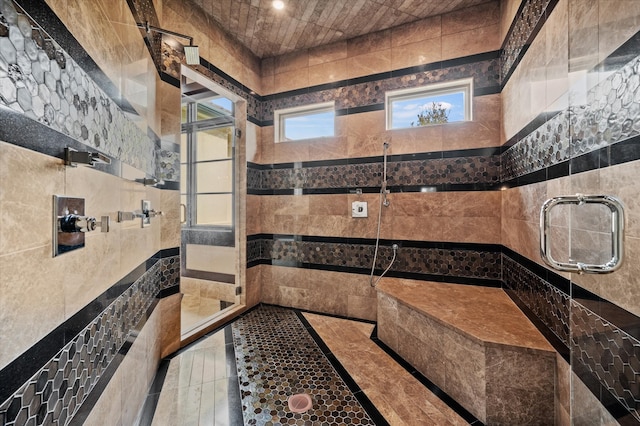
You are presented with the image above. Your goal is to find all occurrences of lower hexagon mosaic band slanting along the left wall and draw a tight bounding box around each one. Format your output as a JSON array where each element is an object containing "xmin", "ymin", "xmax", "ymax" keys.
[{"xmin": 0, "ymin": 259, "xmax": 161, "ymax": 426}]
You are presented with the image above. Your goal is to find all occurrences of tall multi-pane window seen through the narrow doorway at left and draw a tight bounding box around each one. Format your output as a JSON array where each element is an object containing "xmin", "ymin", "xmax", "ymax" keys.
[{"xmin": 180, "ymin": 81, "xmax": 235, "ymax": 228}]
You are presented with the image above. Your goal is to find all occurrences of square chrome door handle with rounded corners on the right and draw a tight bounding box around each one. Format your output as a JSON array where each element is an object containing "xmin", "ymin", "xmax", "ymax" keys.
[{"xmin": 540, "ymin": 194, "xmax": 624, "ymax": 274}]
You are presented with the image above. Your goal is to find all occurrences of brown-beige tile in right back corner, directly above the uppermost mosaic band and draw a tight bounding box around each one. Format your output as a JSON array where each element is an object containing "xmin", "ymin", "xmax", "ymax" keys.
[{"xmin": 442, "ymin": 24, "xmax": 500, "ymax": 60}]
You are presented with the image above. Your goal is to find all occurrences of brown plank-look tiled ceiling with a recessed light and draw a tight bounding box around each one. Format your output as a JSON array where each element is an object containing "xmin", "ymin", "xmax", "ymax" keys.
[{"xmin": 192, "ymin": 0, "xmax": 496, "ymax": 58}]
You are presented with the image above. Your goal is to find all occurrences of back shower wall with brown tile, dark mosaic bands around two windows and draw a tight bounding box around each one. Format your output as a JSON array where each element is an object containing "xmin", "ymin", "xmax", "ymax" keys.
[{"xmin": 247, "ymin": 2, "xmax": 500, "ymax": 319}]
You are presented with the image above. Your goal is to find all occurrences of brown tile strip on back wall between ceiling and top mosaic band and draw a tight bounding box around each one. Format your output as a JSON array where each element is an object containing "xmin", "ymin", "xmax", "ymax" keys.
[{"xmin": 261, "ymin": 1, "xmax": 500, "ymax": 95}]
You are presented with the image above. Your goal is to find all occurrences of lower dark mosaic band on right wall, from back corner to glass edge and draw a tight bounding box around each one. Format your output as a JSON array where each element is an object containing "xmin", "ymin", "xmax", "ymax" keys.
[{"xmin": 502, "ymin": 254, "xmax": 569, "ymax": 346}]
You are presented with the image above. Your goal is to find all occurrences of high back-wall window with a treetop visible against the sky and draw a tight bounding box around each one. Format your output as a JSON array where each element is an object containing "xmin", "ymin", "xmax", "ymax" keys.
[{"xmin": 386, "ymin": 78, "xmax": 473, "ymax": 129}]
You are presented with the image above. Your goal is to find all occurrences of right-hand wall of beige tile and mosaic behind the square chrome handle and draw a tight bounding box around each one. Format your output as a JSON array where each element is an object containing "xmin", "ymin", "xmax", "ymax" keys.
[{"xmin": 502, "ymin": 0, "xmax": 640, "ymax": 424}]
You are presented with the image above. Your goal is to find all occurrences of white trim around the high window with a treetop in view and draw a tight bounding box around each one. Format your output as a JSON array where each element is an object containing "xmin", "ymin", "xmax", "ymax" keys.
[{"xmin": 384, "ymin": 78, "xmax": 473, "ymax": 130}]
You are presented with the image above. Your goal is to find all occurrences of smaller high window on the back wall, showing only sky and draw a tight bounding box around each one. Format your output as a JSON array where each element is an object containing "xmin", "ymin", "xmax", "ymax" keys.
[{"xmin": 273, "ymin": 102, "xmax": 336, "ymax": 142}]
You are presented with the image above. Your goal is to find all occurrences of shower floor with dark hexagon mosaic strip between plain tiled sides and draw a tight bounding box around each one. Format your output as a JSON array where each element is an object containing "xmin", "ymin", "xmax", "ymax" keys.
[{"xmin": 148, "ymin": 306, "xmax": 468, "ymax": 426}]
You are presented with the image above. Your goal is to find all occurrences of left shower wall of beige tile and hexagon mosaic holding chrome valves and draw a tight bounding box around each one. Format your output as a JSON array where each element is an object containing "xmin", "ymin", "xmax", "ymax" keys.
[{"xmin": 0, "ymin": 1, "xmax": 188, "ymax": 425}]
